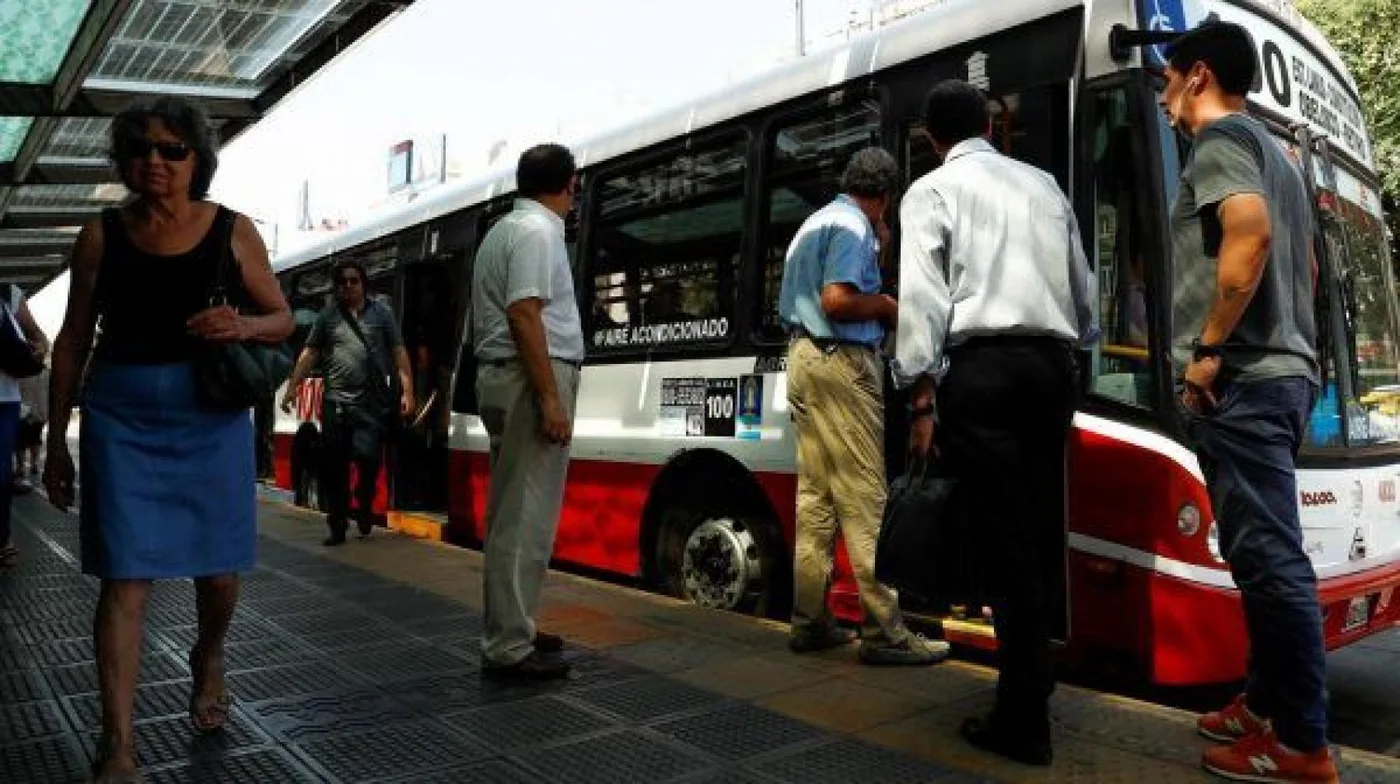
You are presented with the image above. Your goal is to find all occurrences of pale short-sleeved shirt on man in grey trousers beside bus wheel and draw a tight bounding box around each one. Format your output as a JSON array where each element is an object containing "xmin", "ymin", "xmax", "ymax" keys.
[{"xmin": 472, "ymin": 199, "xmax": 584, "ymax": 361}]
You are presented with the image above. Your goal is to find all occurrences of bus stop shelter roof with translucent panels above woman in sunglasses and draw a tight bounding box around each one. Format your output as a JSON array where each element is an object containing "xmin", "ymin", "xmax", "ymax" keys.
[{"xmin": 0, "ymin": 0, "xmax": 413, "ymax": 294}]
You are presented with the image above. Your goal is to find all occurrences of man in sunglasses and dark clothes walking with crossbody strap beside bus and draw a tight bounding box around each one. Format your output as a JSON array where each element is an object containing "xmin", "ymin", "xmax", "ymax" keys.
[{"xmin": 281, "ymin": 260, "xmax": 413, "ymax": 546}]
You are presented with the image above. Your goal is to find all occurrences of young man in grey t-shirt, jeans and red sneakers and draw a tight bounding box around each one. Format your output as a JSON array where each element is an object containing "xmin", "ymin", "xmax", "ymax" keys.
[{"xmin": 1159, "ymin": 22, "xmax": 1337, "ymax": 781}]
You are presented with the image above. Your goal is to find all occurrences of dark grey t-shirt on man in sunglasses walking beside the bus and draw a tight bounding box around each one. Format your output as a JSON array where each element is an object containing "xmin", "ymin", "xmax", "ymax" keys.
[{"xmin": 307, "ymin": 300, "xmax": 403, "ymax": 403}]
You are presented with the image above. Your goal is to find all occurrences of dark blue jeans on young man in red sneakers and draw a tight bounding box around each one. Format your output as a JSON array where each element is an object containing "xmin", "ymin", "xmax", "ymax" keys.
[{"xmin": 1186, "ymin": 378, "xmax": 1327, "ymax": 752}]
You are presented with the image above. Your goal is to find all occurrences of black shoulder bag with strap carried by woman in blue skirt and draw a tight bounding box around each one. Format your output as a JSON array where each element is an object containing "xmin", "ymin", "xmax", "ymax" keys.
[{"xmin": 195, "ymin": 213, "xmax": 291, "ymax": 412}]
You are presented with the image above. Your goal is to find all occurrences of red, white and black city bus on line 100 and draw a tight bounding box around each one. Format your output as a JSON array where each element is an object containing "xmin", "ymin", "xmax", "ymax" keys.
[{"xmin": 274, "ymin": 0, "xmax": 1400, "ymax": 685}]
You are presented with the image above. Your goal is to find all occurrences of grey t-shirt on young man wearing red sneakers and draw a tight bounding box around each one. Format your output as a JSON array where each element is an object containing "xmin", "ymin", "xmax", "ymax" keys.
[{"xmin": 1172, "ymin": 115, "xmax": 1319, "ymax": 384}]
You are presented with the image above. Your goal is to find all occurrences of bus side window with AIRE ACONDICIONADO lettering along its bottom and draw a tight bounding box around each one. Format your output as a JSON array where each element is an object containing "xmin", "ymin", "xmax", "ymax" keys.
[{"xmin": 585, "ymin": 133, "xmax": 748, "ymax": 351}]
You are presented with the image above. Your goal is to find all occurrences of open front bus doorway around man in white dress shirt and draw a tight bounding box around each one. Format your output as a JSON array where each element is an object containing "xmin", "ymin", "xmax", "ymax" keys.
[{"xmin": 888, "ymin": 83, "xmax": 1070, "ymax": 640}]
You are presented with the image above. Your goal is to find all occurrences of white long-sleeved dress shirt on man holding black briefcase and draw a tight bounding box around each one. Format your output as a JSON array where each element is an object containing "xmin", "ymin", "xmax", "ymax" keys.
[{"xmin": 893, "ymin": 139, "xmax": 1098, "ymax": 386}]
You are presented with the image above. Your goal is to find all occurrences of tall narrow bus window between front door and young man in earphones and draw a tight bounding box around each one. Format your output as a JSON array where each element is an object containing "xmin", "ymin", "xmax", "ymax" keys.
[{"xmin": 1088, "ymin": 90, "xmax": 1152, "ymax": 407}]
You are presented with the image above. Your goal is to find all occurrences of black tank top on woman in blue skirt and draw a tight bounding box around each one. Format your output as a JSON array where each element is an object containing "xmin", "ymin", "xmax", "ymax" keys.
[{"xmin": 94, "ymin": 206, "xmax": 244, "ymax": 364}]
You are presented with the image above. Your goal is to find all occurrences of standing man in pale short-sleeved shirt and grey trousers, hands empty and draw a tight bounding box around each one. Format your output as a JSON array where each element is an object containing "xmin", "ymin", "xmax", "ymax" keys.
[{"xmin": 472, "ymin": 144, "xmax": 584, "ymax": 679}]
